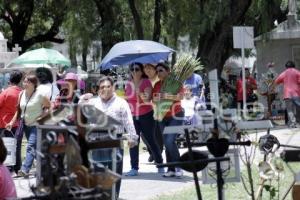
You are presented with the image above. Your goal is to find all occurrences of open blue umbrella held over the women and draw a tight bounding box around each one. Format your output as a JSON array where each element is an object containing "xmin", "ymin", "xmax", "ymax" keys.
[{"xmin": 98, "ymin": 40, "xmax": 174, "ymax": 70}]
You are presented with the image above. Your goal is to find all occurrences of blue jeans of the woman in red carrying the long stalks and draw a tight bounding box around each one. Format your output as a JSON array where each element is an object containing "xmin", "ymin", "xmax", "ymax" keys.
[{"xmin": 159, "ymin": 112, "xmax": 184, "ymax": 171}]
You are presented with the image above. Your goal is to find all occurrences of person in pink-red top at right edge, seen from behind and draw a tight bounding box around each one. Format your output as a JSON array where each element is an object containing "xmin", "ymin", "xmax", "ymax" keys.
[{"xmin": 275, "ymin": 61, "xmax": 300, "ymax": 128}]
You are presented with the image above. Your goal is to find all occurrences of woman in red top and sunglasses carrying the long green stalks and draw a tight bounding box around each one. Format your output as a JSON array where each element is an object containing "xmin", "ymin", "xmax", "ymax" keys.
[{"xmin": 152, "ymin": 63, "xmax": 184, "ymax": 178}]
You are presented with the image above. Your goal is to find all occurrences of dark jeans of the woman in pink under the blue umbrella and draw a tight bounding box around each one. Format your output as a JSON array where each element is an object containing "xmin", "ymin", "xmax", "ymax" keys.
[{"xmin": 129, "ymin": 111, "xmax": 163, "ymax": 170}]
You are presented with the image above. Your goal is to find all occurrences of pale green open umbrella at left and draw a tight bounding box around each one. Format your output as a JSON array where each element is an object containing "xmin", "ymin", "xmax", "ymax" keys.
[{"xmin": 11, "ymin": 48, "xmax": 71, "ymax": 66}]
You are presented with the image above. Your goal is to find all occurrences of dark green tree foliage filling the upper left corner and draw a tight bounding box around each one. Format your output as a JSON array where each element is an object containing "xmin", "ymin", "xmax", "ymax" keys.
[{"xmin": 0, "ymin": 0, "xmax": 69, "ymax": 50}]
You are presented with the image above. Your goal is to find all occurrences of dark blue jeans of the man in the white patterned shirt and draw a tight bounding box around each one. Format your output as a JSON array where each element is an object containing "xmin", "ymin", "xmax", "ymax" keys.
[{"xmin": 91, "ymin": 148, "xmax": 124, "ymax": 199}]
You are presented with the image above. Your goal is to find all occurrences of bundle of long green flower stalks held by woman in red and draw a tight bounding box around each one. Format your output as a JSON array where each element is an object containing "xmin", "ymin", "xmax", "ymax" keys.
[{"xmin": 155, "ymin": 55, "xmax": 203, "ymax": 121}]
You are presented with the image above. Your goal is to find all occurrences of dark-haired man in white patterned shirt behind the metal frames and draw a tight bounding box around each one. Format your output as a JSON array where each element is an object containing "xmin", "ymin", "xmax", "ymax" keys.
[{"xmin": 79, "ymin": 76, "xmax": 138, "ymax": 197}]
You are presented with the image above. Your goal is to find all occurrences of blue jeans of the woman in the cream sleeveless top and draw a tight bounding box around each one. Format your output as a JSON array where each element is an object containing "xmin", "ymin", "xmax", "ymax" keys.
[{"xmin": 21, "ymin": 125, "xmax": 37, "ymax": 173}]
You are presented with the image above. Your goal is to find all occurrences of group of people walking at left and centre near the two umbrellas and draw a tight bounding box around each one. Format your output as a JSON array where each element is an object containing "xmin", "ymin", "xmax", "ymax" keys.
[{"xmin": 0, "ymin": 63, "xmax": 204, "ymax": 198}]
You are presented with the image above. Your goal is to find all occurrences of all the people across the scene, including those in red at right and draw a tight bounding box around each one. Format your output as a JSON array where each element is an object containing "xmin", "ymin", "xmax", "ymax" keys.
[{"xmin": 0, "ymin": 61, "xmax": 300, "ymax": 197}]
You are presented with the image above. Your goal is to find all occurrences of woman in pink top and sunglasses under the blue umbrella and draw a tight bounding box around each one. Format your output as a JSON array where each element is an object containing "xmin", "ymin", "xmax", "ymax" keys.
[{"xmin": 125, "ymin": 63, "xmax": 163, "ymax": 176}]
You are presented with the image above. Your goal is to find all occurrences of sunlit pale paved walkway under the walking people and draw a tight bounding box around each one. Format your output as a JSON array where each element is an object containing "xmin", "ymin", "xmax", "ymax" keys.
[{"xmin": 15, "ymin": 129, "xmax": 300, "ymax": 200}]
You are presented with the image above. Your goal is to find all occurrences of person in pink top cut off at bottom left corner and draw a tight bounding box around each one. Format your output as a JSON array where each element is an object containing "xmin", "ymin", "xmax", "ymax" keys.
[{"xmin": 0, "ymin": 137, "xmax": 17, "ymax": 199}]
